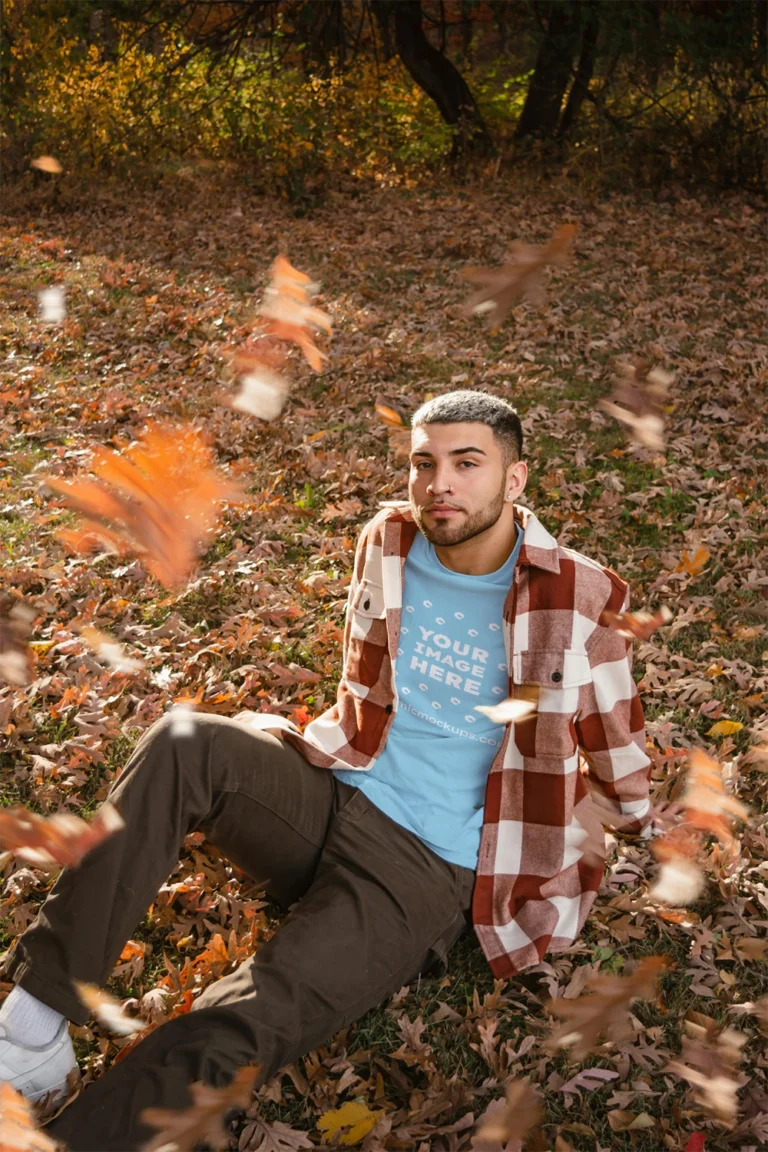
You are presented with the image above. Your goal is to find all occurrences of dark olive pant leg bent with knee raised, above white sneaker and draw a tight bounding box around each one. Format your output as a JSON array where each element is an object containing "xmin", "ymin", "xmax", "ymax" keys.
[{"xmin": 7, "ymin": 714, "xmax": 345, "ymax": 1024}]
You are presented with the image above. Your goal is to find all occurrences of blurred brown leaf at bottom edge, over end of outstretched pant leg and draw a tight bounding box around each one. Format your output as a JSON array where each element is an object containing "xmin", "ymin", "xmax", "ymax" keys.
[{"xmin": 139, "ymin": 1064, "xmax": 259, "ymax": 1152}]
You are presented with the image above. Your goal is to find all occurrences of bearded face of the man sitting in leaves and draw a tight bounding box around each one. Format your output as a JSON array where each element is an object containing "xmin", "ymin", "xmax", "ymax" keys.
[{"xmin": 408, "ymin": 423, "xmax": 511, "ymax": 547}]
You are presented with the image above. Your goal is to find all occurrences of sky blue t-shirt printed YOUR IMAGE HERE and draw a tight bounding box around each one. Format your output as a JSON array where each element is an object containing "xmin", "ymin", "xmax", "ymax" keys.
[{"xmin": 337, "ymin": 530, "xmax": 523, "ymax": 869}]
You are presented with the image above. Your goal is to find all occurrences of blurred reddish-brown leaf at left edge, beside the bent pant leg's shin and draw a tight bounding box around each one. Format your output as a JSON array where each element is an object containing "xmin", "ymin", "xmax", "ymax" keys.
[{"xmin": 0, "ymin": 801, "xmax": 126, "ymax": 869}]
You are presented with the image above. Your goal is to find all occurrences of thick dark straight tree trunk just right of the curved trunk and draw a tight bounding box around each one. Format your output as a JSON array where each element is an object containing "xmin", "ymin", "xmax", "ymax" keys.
[{"xmin": 516, "ymin": 0, "xmax": 581, "ymax": 138}]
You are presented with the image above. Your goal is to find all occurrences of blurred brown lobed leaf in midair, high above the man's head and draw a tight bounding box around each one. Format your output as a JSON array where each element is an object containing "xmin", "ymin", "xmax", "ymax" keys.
[{"xmin": 462, "ymin": 223, "xmax": 577, "ymax": 328}]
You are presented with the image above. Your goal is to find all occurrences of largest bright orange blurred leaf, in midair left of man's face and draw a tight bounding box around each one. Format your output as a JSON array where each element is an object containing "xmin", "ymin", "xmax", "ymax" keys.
[{"xmin": 46, "ymin": 424, "xmax": 239, "ymax": 588}]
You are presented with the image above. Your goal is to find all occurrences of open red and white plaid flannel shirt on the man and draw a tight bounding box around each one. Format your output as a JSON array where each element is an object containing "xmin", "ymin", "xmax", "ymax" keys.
[{"xmin": 284, "ymin": 503, "xmax": 651, "ymax": 977}]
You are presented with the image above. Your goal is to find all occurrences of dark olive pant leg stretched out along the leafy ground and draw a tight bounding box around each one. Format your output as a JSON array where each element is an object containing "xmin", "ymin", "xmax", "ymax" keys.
[{"xmin": 45, "ymin": 791, "xmax": 474, "ymax": 1152}]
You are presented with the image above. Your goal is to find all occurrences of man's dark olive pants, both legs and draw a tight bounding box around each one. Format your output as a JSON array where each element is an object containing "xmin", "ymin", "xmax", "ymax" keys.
[{"xmin": 8, "ymin": 715, "xmax": 474, "ymax": 1152}]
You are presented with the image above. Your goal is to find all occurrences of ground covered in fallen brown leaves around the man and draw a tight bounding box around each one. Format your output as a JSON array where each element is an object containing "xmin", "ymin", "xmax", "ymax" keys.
[{"xmin": 0, "ymin": 172, "xmax": 768, "ymax": 1152}]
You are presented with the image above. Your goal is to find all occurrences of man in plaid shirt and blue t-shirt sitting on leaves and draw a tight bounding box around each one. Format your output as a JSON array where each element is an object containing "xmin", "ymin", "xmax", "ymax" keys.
[{"xmin": 0, "ymin": 391, "xmax": 651, "ymax": 1152}]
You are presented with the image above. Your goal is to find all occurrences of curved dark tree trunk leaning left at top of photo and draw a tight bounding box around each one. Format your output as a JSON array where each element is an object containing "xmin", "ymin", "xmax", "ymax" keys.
[{"xmin": 395, "ymin": 0, "xmax": 491, "ymax": 153}]
